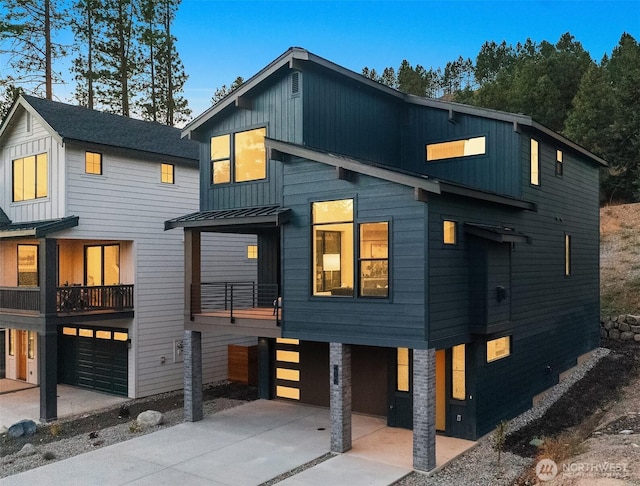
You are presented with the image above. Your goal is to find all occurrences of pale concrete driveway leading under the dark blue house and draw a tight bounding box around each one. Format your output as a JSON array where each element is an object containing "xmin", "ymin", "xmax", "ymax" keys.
[{"xmin": 0, "ymin": 400, "xmax": 475, "ymax": 486}]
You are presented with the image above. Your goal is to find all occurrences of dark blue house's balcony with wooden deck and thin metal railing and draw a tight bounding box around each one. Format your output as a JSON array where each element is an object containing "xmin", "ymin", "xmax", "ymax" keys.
[{"xmin": 185, "ymin": 282, "xmax": 282, "ymax": 337}]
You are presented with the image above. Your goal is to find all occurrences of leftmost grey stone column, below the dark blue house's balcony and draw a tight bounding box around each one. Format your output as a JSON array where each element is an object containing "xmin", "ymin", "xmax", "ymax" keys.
[{"xmin": 183, "ymin": 331, "xmax": 203, "ymax": 422}]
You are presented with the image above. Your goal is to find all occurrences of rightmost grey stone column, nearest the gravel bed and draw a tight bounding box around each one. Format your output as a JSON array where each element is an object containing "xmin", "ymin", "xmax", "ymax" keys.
[{"xmin": 413, "ymin": 349, "xmax": 436, "ymax": 471}]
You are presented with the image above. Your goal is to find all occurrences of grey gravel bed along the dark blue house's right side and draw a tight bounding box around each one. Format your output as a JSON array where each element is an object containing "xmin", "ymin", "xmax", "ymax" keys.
[{"xmin": 395, "ymin": 348, "xmax": 610, "ymax": 486}]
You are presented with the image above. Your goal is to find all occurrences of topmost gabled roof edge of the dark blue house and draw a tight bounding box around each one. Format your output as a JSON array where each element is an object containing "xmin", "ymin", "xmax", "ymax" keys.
[{"xmin": 182, "ymin": 47, "xmax": 608, "ymax": 166}]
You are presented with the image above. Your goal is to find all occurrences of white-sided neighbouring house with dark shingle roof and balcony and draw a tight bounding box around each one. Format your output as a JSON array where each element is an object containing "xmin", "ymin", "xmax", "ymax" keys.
[{"xmin": 0, "ymin": 96, "xmax": 256, "ymax": 420}]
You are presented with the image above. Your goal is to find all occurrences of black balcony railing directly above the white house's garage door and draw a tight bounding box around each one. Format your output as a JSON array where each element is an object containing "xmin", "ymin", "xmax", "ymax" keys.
[{"xmin": 56, "ymin": 285, "xmax": 133, "ymax": 313}]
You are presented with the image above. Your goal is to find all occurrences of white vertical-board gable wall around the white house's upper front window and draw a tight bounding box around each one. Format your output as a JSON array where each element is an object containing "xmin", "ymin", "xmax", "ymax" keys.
[{"xmin": 0, "ymin": 108, "xmax": 66, "ymax": 223}]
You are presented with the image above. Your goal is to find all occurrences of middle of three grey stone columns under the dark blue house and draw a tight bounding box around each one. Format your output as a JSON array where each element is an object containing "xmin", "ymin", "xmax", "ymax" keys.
[{"xmin": 329, "ymin": 343, "xmax": 351, "ymax": 452}]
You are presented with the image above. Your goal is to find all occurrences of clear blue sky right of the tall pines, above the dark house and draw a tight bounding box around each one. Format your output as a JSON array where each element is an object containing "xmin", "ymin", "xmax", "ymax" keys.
[{"xmin": 173, "ymin": 0, "xmax": 640, "ymax": 116}]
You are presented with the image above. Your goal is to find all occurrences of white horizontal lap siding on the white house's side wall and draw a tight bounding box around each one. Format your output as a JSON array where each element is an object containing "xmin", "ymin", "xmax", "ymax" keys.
[{"xmin": 57, "ymin": 142, "xmax": 255, "ymax": 397}]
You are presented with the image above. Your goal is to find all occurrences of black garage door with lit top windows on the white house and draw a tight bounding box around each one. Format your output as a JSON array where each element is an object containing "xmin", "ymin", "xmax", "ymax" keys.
[{"xmin": 58, "ymin": 326, "xmax": 129, "ymax": 397}]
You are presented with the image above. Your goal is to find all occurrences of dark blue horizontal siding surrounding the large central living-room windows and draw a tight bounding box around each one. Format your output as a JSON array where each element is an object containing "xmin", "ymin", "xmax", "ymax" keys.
[{"xmin": 282, "ymin": 159, "xmax": 426, "ymax": 347}]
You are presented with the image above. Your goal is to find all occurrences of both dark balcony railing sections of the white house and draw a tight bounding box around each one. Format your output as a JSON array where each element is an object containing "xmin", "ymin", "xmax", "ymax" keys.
[{"xmin": 0, "ymin": 285, "xmax": 133, "ymax": 315}]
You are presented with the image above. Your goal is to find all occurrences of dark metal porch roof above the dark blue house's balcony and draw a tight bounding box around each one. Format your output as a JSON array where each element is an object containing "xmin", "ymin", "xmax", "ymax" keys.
[{"xmin": 164, "ymin": 205, "xmax": 291, "ymax": 231}]
